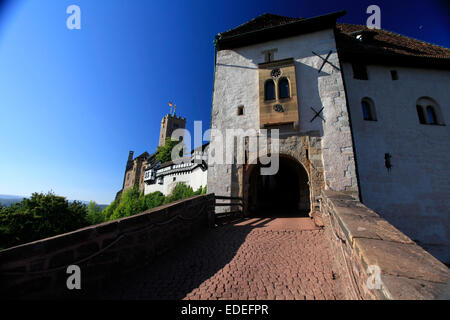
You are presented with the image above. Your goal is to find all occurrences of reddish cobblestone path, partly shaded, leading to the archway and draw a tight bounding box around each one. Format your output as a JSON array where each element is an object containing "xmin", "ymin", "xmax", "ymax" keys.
[{"xmin": 100, "ymin": 218, "xmax": 344, "ymax": 300}]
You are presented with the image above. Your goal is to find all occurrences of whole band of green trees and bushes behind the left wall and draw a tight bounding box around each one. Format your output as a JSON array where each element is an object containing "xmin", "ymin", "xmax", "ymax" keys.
[{"xmin": 0, "ymin": 183, "xmax": 206, "ymax": 250}]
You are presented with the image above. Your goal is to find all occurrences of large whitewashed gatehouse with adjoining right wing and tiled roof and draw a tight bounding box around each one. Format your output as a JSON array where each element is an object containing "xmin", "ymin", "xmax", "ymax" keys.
[{"xmin": 207, "ymin": 12, "xmax": 450, "ymax": 263}]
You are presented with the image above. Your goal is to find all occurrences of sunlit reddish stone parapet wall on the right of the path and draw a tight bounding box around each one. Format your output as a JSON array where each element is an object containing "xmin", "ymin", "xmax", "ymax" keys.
[{"xmin": 320, "ymin": 190, "xmax": 450, "ymax": 300}]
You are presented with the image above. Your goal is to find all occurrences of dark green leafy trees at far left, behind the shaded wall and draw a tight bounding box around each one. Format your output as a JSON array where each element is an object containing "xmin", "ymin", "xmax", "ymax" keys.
[{"xmin": 0, "ymin": 192, "xmax": 88, "ymax": 248}]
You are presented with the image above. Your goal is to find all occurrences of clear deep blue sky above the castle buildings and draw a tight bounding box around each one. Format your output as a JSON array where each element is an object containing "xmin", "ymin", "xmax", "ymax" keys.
[{"xmin": 0, "ymin": 0, "xmax": 450, "ymax": 203}]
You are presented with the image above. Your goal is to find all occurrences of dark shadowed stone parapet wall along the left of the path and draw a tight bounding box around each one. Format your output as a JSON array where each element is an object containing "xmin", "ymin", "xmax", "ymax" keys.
[{"xmin": 0, "ymin": 194, "xmax": 214, "ymax": 299}]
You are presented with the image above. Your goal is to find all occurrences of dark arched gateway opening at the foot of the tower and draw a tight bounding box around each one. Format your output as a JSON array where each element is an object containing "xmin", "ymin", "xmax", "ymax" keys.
[{"xmin": 247, "ymin": 155, "xmax": 310, "ymax": 216}]
